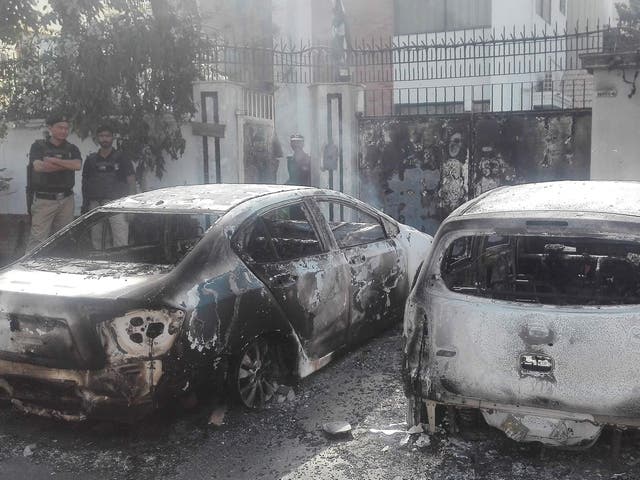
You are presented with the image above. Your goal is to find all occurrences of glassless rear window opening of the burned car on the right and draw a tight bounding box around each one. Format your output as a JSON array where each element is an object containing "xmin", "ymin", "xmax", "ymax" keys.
[{"xmin": 441, "ymin": 235, "xmax": 640, "ymax": 305}]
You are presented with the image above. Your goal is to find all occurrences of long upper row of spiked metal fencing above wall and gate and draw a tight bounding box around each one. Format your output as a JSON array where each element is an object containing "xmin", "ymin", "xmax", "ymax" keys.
[{"xmin": 198, "ymin": 25, "xmax": 616, "ymax": 84}]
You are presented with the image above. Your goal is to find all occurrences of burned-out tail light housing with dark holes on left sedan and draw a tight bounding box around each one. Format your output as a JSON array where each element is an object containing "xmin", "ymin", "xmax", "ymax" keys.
[{"xmin": 98, "ymin": 308, "xmax": 184, "ymax": 360}]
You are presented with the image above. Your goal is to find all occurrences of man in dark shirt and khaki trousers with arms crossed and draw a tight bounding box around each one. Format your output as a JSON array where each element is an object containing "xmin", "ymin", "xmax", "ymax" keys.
[{"xmin": 27, "ymin": 113, "xmax": 82, "ymax": 251}]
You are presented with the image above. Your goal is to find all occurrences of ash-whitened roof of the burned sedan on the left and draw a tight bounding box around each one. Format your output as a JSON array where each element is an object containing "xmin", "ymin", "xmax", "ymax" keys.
[{"xmin": 104, "ymin": 183, "xmax": 316, "ymax": 212}]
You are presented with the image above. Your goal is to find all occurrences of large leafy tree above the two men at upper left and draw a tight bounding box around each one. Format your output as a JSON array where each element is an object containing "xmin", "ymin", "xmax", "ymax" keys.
[{"xmin": 0, "ymin": 0, "xmax": 206, "ymax": 176}]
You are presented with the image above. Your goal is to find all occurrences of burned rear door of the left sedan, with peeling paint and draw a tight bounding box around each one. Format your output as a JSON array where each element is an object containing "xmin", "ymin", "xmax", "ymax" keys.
[{"xmin": 234, "ymin": 202, "xmax": 349, "ymax": 358}]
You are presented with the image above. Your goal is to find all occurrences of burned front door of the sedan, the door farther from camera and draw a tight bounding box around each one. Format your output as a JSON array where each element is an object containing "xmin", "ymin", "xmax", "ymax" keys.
[{"xmin": 316, "ymin": 198, "xmax": 406, "ymax": 343}]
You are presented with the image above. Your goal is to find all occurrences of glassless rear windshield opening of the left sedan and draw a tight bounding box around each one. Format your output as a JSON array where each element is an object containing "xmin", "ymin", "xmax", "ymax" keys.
[{"xmin": 35, "ymin": 212, "xmax": 219, "ymax": 265}]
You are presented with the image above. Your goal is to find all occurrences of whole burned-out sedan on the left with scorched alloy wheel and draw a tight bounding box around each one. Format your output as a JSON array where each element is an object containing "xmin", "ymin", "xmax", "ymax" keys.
[{"xmin": 0, "ymin": 185, "xmax": 431, "ymax": 419}]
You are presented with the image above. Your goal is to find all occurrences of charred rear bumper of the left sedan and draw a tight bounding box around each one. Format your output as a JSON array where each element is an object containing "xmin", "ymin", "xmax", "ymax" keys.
[{"xmin": 0, "ymin": 359, "xmax": 163, "ymax": 421}]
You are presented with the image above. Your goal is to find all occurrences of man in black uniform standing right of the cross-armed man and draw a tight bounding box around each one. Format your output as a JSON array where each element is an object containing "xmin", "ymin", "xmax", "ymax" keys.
[{"xmin": 82, "ymin": 125, "xmax": 136, "ymax": 250}]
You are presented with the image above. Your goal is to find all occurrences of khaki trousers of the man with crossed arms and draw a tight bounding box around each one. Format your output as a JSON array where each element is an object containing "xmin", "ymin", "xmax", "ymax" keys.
[{"xmin": 26, "ymin": 195, "xmax": 75, "ymax": 252}]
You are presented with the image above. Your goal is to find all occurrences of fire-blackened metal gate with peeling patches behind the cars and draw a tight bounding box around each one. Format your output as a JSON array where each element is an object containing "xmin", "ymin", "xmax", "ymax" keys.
[{"xmin": 359, "ymin": 109, "xmax": 591, "ymax": 234}]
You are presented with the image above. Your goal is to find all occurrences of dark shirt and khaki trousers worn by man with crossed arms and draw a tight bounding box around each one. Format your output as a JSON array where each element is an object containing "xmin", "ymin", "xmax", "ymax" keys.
[{"xmin": 27, "ymin": 140, "xmax": 81, "ymax": 251}]
